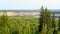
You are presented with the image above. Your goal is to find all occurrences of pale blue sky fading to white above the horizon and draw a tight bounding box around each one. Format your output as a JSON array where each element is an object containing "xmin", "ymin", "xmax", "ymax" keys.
[{"xmin": 0, "ymin": 0, "xmax": 60, "ymax": 10}]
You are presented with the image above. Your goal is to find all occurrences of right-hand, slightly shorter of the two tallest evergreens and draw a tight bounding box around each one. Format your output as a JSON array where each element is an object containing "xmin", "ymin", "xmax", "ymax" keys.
[{"xmin": 45, "ymin": 8, "xmax": 52, "ymax": 34}]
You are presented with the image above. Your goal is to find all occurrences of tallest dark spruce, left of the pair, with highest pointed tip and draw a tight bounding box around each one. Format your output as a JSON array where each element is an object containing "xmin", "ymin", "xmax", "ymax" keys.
[{"xmin": 39, "ymin": 6, "xmax": 46, "ymax": 34}]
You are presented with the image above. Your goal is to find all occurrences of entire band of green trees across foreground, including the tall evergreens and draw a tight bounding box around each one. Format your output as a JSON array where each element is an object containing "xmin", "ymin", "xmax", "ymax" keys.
[{"xmin": 0, "ymin": 6, "xmax": 60, "ymax": 34}]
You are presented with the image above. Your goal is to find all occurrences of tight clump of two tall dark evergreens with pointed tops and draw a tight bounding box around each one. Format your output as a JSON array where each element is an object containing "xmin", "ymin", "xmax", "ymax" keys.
[{"xmin": 39, "ymin": 6, "xmax": 51, "ymax": 34}]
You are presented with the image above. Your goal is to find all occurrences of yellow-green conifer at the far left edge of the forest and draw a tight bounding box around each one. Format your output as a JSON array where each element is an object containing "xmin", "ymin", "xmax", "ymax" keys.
[{"xmin": 0, "ymin": 11, "xmax": 10, "ymax": 34}]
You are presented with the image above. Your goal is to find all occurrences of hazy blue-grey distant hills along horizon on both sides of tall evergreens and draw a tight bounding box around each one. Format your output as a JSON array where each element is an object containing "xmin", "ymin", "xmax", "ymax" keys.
[{"xmin": 0, "ymin": 9, "xmax": 60, "ymax": 13}]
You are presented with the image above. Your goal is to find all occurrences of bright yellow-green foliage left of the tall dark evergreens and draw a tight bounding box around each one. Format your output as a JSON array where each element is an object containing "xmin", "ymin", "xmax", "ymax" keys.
[{"xmin": 0, "ymin": 13, "xmax": 39, "ymax": 34}]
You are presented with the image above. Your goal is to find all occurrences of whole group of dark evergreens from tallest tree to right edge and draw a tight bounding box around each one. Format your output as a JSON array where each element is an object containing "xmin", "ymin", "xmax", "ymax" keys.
[{"xmin": 39, "ymin": 6, "xmax": 60, "ymax": 34}]
